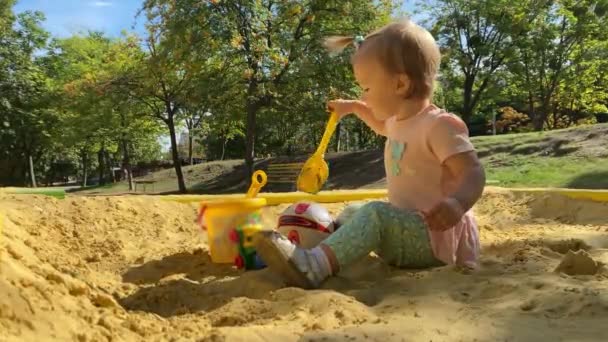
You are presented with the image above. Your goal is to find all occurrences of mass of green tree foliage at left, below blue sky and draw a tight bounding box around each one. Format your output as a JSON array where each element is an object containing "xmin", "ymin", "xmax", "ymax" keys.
[{"xmin": 0, "ymin": 2, "xmax": 166, "ymax": 185}]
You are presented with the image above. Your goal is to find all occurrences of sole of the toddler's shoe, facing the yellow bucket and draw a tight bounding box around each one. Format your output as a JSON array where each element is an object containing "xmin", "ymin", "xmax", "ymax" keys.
[{"xmin": 254, "ymin": 231, "xmax": 314, "ymax": 289}]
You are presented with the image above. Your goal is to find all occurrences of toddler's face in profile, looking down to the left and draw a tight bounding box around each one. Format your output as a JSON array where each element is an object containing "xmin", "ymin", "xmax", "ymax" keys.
[{"xmin": 353, "ymin": 57, "xmax": 409, "ymax": 121}]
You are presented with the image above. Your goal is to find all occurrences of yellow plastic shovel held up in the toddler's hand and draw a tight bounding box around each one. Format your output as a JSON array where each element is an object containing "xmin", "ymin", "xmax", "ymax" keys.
[{"xmin": 297, "ymin": 112, "xmax": 338, "ymax": 194}]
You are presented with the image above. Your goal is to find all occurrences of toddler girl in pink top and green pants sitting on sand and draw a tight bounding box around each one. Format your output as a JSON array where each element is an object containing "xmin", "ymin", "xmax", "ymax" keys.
[{"xmin": 255, "ymin": 20, "xmax": 485, "ymax": 288}]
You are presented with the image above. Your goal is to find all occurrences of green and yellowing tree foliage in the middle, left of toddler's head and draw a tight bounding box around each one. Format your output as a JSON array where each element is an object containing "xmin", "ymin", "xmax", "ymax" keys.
[{"xmin": 140, "ymin": 0, "xmax": 393, "ymax": 172}]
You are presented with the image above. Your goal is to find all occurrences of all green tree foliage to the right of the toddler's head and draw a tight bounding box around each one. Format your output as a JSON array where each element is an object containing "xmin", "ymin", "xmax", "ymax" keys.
[{"xmin": 426, "ymin": 0, "xmax": 608, "ymax": 130}]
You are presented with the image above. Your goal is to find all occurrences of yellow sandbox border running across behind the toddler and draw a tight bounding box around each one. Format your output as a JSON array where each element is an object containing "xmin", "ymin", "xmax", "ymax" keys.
[{"xmin": 161, "ymin": 187, "xmax": 608, "ymax": 205}]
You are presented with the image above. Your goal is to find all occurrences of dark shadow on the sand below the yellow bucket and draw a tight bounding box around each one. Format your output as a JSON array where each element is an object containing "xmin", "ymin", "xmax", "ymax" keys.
[{"xmin": 117, "ymin": 249, "xmax": 284, "ymax": 317}]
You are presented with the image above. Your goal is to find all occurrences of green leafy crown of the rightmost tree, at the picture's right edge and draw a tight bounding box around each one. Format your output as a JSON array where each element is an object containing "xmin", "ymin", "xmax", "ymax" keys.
[{"xmin": 510, "ymin": 0, "xmax": 608, "ymax": 129}]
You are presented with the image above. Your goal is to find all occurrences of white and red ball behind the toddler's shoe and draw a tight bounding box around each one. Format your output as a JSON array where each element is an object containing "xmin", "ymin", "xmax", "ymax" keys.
[{"xmin": 277, "ymin": 202, "xmax": 334, "ymax": 248}]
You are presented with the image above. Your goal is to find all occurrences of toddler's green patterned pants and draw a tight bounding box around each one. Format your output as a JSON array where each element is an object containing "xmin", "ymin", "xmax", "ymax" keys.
[{"xmin": 322, "ymin": 201, "xmax": 443, "ymax": 268}]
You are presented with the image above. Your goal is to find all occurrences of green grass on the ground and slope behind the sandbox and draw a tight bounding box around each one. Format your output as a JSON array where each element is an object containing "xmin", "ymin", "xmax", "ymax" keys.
[{"xmin": 65, "ymin": 124, "xmax": 608, "ymax": 194}]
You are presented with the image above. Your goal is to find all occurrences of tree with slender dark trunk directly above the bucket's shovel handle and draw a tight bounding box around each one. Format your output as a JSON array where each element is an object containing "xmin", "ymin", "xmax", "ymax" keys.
[{"xmin": 212, "ymin": 0, "xmax": 400, "ymax": 174}]
